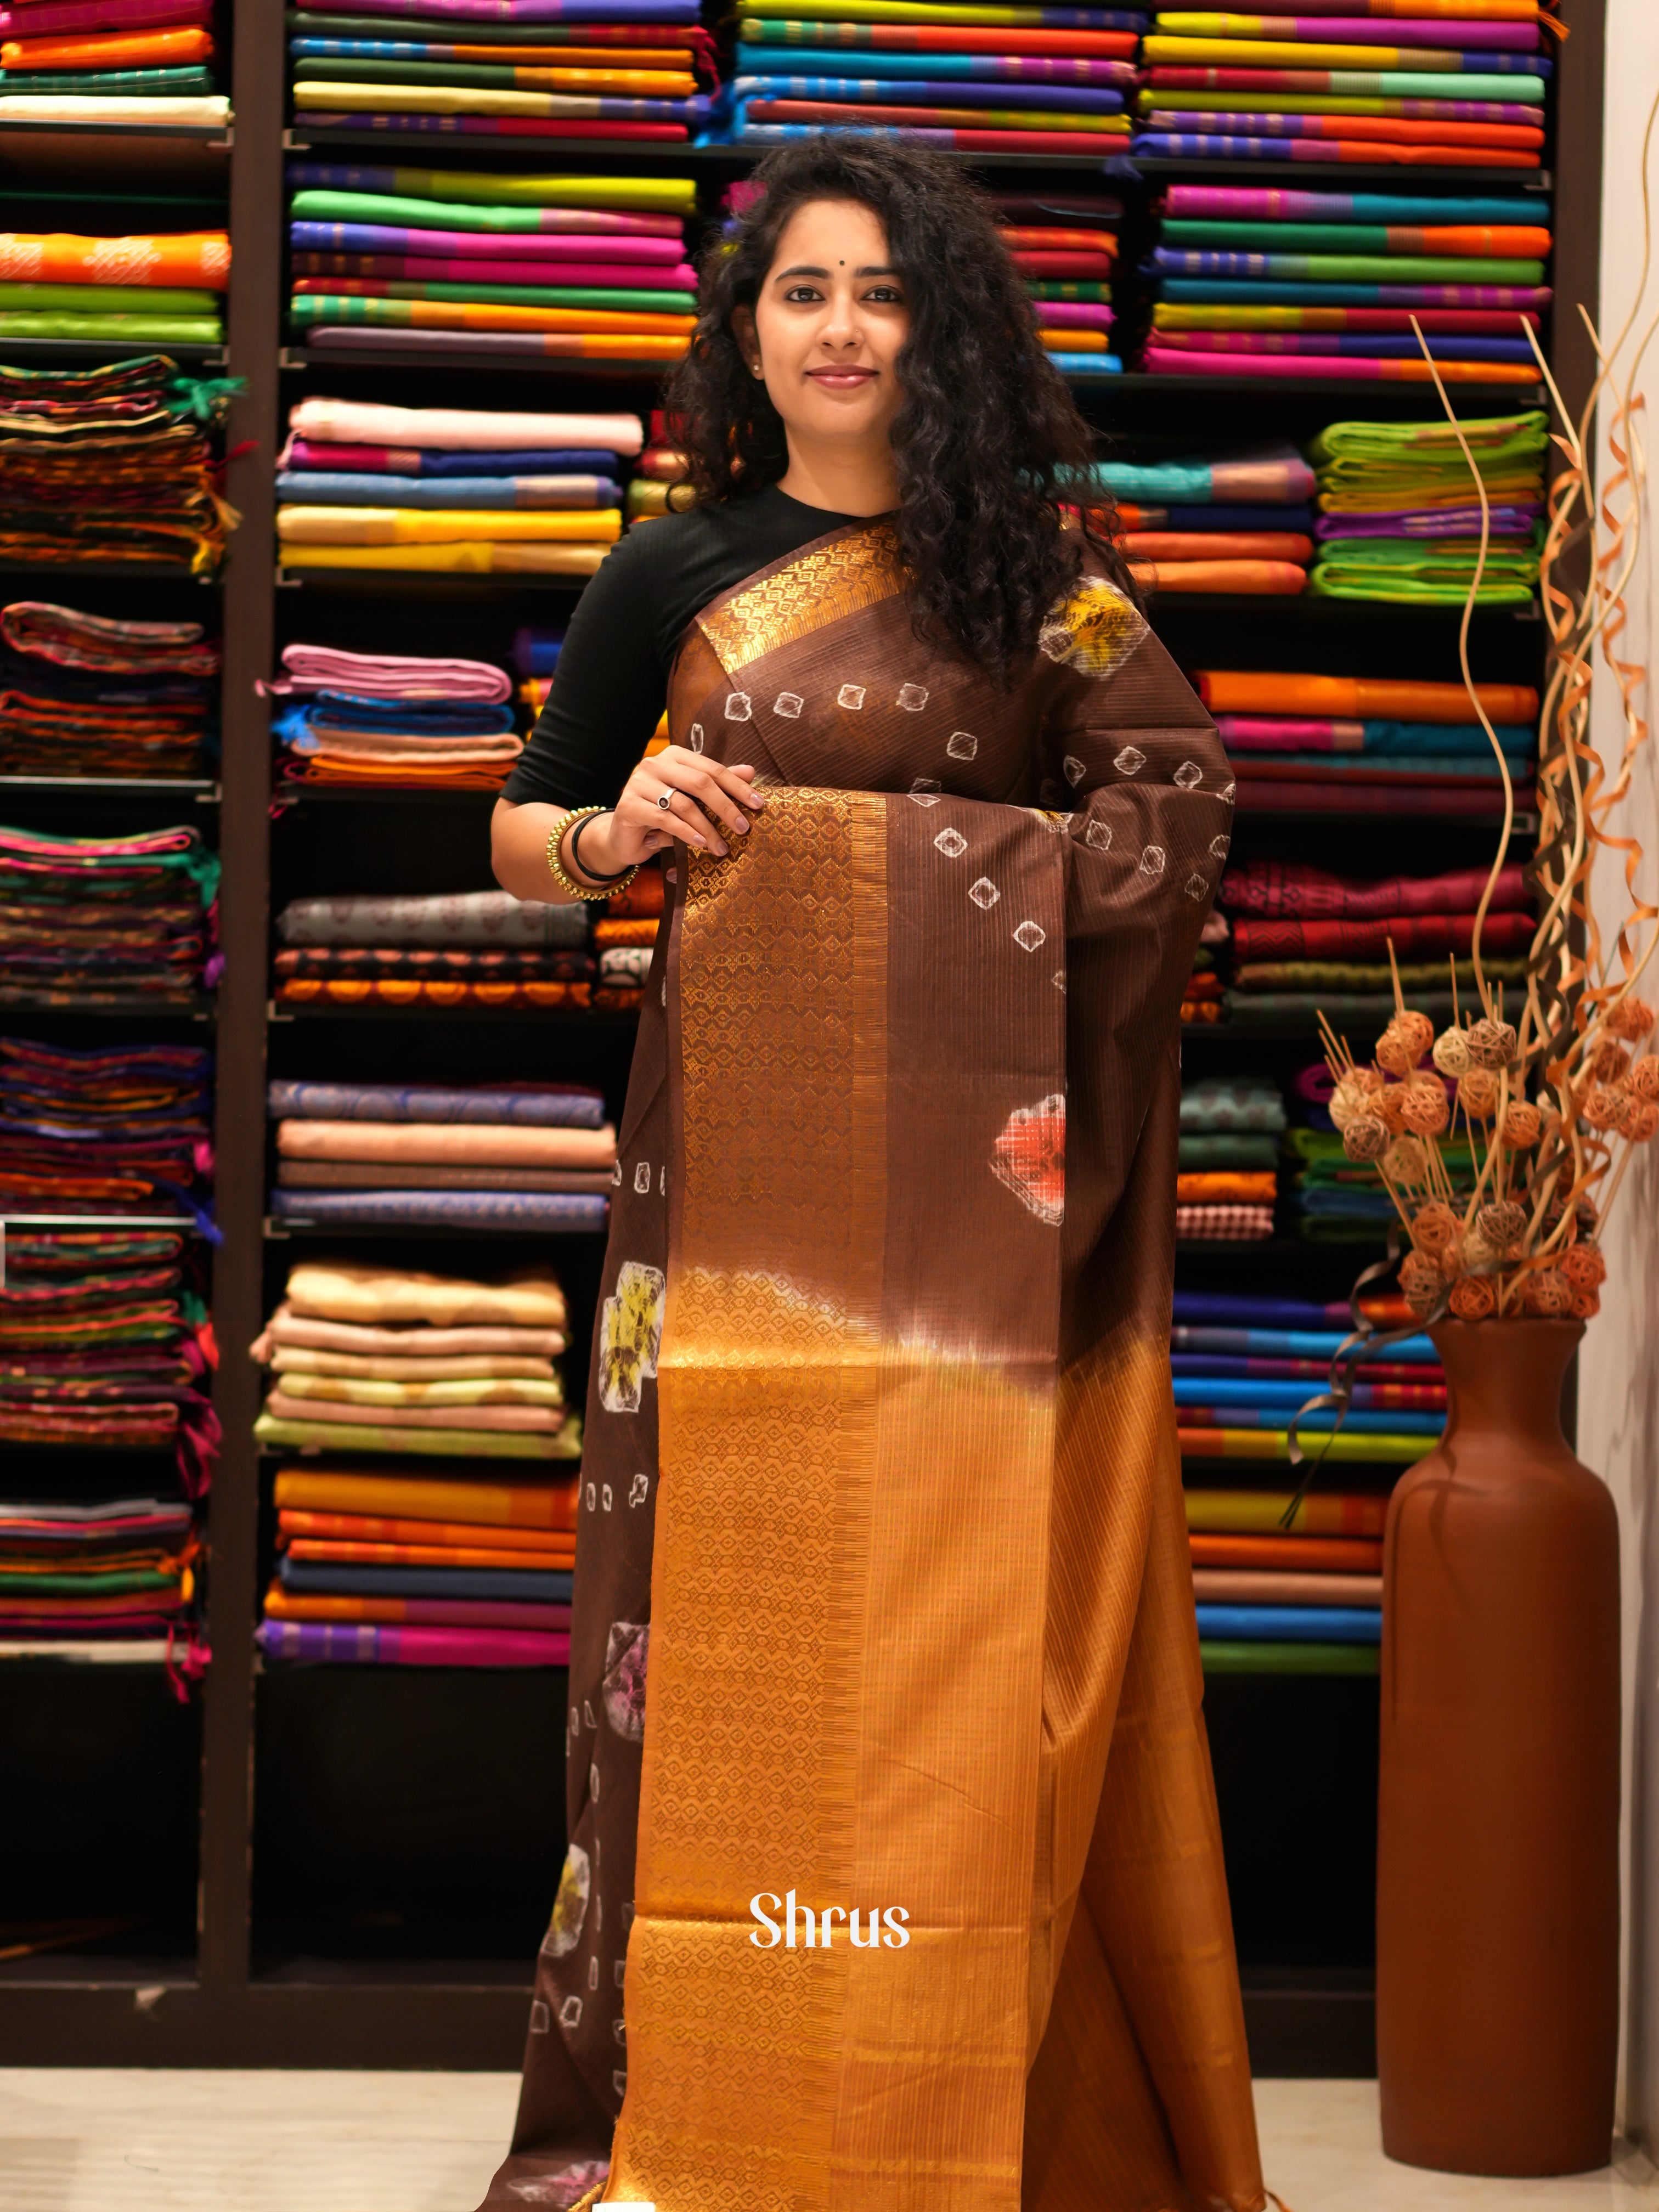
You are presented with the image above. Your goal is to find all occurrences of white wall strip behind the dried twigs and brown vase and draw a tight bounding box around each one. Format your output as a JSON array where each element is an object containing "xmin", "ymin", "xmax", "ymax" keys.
[{"xmin": 1558, "ymin": 0, "xmax": 1659, "ymax": 2159}]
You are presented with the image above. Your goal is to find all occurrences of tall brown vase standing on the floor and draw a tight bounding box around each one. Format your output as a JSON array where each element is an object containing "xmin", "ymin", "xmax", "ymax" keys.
[{"xmin": 1376, "ymin": 1321, "xmax": 1619, "ymax": 2174}]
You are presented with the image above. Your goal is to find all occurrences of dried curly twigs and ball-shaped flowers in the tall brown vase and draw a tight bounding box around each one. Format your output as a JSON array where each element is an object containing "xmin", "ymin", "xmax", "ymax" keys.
[{"xmin": 1321, "ymin": 99, "xmax": 1659, "ymax": 1321}]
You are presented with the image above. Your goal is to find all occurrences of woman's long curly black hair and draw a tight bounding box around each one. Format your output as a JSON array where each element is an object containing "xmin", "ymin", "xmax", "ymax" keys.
[{"xmin": 664, "ymin": 135, "xmax": 1135, "ymax": 684}]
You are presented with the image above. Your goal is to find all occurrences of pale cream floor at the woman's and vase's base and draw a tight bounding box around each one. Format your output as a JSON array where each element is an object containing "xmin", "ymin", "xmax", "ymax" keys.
[{"xmin": 0, "ymin": 2068, "xmax": 1659, "ymax": 2212}]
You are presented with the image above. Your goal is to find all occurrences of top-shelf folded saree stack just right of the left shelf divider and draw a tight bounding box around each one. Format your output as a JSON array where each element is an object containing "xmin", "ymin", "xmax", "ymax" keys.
[{"xmin": 287, "ymin": 0, "xmax": 714, "ymax": 142}]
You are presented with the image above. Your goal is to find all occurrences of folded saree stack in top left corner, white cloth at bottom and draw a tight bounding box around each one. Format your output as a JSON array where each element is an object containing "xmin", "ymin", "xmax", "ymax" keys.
[{"xmin": 0, "ymin": 0, "xmax": 230, "ymax": 131}]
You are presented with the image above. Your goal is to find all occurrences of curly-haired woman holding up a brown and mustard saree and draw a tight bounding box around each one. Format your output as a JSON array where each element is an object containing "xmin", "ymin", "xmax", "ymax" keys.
[{"xmin": 489, "ymin": 137, "xmax": 1263, "ymax": 2212}]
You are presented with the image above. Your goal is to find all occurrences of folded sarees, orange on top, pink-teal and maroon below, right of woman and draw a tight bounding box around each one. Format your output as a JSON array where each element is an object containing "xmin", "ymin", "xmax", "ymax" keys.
[{"xmin": 1192, "ymin": 668, "xmax": 1537, "ymax": 816}]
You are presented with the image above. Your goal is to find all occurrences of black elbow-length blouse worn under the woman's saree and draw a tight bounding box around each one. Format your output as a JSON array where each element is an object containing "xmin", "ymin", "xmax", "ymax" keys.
[{"xmin": 502, "ymin": 484, "xmax": 858, "ymax": 808}]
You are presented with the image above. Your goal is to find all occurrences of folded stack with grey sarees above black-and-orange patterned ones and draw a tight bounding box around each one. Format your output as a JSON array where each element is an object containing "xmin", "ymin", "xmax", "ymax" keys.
[{"xmin": 274, "ymin": 891, "xmax": 595, "ymax": 1013}]
